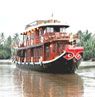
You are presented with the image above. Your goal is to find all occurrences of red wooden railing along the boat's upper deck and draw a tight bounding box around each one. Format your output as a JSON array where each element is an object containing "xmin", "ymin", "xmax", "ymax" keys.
[{"xmin": 20, "ymin": 32, "xmax": 79, "ymax": 47}]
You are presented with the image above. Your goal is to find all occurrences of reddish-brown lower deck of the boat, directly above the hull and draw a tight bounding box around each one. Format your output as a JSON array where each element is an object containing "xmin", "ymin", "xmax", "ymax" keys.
[{"xmin": 16, "ymin": 41, "xmax": 69, "ymax": 62}]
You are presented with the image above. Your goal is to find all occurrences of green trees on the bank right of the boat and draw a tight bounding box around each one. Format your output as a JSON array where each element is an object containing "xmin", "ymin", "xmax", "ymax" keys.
[{"xmin": 78, "ymin": 30, "xmax": 95, "ymax": 60}]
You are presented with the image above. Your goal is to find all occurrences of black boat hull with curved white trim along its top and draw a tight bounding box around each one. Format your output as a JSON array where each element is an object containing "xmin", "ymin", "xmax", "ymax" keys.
[{"xmin": 17, "ymin": 54, "xmax": 81, "ymax": 73}]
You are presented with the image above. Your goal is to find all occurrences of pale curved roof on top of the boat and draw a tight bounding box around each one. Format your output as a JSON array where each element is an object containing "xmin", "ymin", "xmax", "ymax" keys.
[{"xmin": 25, "ymin": 20, "xmax": 69, "ymax": 31}]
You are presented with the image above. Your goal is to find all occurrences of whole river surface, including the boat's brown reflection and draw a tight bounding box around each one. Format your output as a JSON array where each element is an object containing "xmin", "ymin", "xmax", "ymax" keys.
[{"xmin": 0, "ymin": 62, "xmax": 95, "ymax": 97}]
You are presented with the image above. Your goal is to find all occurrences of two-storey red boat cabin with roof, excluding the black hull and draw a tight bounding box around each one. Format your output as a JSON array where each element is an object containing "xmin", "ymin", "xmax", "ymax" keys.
[{"xmin": 17, "ymin": 20, "xmax": 78, "ymax": 62}]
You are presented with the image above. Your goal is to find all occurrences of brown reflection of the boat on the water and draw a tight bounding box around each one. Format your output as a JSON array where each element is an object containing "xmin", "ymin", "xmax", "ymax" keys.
[{"xmin": 14, "ymin": 69, "xmax": 83, "ymax": 97}]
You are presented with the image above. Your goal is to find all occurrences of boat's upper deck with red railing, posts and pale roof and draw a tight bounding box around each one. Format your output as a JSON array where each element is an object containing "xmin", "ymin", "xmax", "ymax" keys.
[{"xmin": 18, "ymin": 19, "xmax": 78, "ymax": 47}]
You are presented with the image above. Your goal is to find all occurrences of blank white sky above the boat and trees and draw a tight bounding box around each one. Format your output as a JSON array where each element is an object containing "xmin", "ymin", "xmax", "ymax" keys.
[{"xmin": 0, "ymin": 0, "xmax": 95, "ymax": 36}]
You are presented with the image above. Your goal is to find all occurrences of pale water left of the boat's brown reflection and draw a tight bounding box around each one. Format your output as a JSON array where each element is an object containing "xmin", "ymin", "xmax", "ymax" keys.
[{"xmin": 0, "ymin": 65, "xmax": 19, "ymax": 97}]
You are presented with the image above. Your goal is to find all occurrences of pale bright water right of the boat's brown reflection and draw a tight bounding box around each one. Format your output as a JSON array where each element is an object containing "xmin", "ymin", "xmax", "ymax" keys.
[{"xmin": 77, "ymin": 66, "xmax": 95, "ymax": 97}]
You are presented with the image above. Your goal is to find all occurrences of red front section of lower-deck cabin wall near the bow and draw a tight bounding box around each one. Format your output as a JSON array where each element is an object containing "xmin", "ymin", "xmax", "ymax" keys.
[{"xmin": 44, "ymin": 41, "xmax": 66, "ymax": 60}]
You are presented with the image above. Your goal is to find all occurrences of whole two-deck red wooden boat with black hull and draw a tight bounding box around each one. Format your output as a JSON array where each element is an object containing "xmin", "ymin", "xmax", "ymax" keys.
[{"xmin": 15, "ymin": 19, "xmax": 84, "ymax": 73}]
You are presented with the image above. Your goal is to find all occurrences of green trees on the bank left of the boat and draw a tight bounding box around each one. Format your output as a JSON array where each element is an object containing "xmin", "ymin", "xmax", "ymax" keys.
[{"xmin": 0, "ymin": 33, "xmax": 19, "ymax": 59}]
